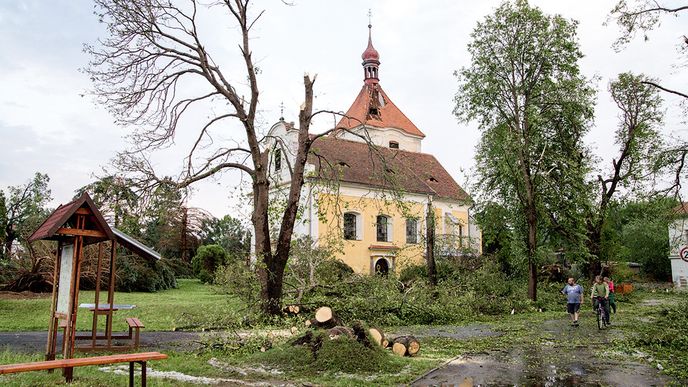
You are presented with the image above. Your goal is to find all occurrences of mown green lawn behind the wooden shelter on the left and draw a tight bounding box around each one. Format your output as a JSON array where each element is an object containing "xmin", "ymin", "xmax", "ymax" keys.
[{"xmin": 0, "ymin": 279, "xmax": 240, "ymax": 332}]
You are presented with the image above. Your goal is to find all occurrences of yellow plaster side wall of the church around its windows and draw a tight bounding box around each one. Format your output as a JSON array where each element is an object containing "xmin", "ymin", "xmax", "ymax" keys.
[{"xmin": 317, "ymin": 193, "xmax": 468, "ymax": 274}]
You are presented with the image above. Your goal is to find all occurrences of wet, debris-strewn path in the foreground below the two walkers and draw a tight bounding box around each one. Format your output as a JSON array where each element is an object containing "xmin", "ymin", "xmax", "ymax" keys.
[{"xmin": 412, "ymin": 319, "xmax": 667, "ymax": 386}]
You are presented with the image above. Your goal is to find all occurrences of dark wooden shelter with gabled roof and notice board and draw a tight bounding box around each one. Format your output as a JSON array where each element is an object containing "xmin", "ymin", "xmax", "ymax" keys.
[{"xmin": 29, "ymin": 192, "xmax": 160, "ymax": 378}]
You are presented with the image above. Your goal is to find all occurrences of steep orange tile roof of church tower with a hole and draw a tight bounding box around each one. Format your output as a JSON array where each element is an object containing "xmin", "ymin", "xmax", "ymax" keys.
[{"xmin": 336, "ymin": 83, "xmax": 425, "ymax": 138}]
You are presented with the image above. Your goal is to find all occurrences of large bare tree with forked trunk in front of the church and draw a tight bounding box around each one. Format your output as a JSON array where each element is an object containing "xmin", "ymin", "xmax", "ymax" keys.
[{"xmin": 85, "ymin": 0, "xmax": 315, "ymax": 314}]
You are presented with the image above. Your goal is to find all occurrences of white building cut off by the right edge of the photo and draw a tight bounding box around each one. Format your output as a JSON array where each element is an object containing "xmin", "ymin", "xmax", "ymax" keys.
[{"xmin": 669, "ymin": 202, "xmax": 688, "ymax": 288}]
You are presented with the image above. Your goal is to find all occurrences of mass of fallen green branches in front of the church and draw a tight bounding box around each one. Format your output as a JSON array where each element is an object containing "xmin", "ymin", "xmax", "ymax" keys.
[{"xmin": 302, "ymin": 258, "xmax": 561, "ymax": 326}]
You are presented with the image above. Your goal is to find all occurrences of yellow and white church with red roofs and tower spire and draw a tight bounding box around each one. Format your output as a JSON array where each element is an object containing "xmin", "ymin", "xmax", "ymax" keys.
[{"xmin": 268, "ymin": 25, "xmax": 481, "ymax": 274}]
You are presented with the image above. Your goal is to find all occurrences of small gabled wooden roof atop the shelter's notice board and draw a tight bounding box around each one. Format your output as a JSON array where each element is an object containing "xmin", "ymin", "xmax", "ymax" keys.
[{"xmin": 29, "ymin": 192, "xmax": 115, "ymax": 245}]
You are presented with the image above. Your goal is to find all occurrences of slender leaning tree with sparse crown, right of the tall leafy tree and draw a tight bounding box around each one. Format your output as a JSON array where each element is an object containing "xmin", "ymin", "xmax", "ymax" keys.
[{"xmin": 588, "ymin": 73, "xmax": 664, "ymax": 276}]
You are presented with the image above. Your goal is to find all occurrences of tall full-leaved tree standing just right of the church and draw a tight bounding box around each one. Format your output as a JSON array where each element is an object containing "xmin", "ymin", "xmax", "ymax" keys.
[{"xmin": 454, "ymin": 0, "xmax": 595, "ymax": 300}]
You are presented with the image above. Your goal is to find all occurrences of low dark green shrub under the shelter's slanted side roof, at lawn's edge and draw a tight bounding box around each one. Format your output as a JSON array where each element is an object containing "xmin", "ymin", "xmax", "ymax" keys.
[{"xmin": 115, "ymin": 255, "xmax": 177, "ymax": 292}]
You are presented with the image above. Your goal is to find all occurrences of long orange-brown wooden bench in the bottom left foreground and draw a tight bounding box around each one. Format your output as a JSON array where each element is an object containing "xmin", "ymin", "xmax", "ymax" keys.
[{"xmin": 0, "ymin": 352, "xmax": 167, "ymax": 387}]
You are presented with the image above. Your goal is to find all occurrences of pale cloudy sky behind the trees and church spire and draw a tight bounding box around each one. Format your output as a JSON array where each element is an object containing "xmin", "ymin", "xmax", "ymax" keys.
[{"xmin": 0, "ymin": 0, "xmax": 688, "ymax": 216}]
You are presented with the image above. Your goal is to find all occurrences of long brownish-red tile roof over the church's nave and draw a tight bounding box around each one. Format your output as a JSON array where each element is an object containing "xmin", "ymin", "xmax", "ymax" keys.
[{"xmin": 308, "ymin": 136, "xmax": 470, "ymax": 201}]
